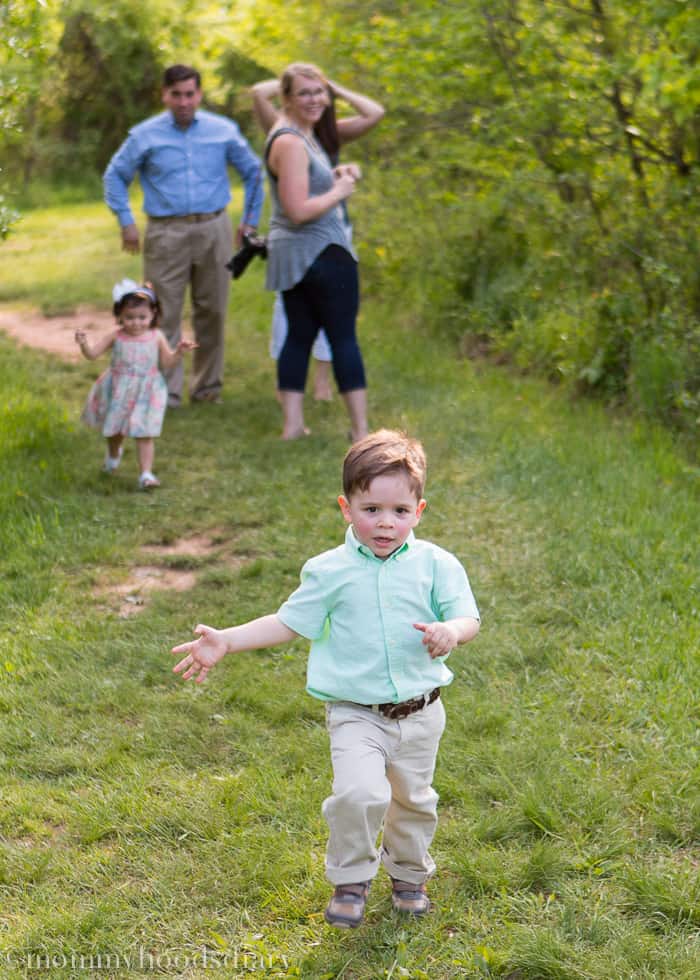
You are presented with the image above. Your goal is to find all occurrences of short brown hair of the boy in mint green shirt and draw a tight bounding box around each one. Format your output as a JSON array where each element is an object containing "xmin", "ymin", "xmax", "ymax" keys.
[{"xmin": 343, "ymin": 429, "xmax": 427, "ymax": 500}]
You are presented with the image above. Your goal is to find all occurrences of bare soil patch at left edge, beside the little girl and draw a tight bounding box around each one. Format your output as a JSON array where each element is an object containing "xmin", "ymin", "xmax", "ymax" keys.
[{"xmin": 0, "ymin": 306, "xmax": 114, "ymax": 361}]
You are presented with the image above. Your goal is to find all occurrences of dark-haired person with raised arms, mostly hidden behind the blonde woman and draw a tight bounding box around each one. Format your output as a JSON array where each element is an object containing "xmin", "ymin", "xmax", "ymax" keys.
[{"xmin": 251, "ymin": 78, "xmax": 384, "ymax": 401}]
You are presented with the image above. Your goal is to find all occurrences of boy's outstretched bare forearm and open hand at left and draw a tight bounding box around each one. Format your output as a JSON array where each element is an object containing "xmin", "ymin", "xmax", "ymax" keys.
[{"xmin": 171, "ymin": 613, "xmax": 299, "ymax": 684}]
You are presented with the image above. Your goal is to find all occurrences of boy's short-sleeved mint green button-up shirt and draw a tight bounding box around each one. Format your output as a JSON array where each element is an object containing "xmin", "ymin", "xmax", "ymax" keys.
[{"xmin": 277, "ymin": 527, "xmax": 479, "ymax": 704}]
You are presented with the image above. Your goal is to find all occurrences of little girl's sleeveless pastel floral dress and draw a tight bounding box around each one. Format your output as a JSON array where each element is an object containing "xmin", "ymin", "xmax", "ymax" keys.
[{"xmin": 82, "ymin": 330, "xmax": 168, "ymax": 439}]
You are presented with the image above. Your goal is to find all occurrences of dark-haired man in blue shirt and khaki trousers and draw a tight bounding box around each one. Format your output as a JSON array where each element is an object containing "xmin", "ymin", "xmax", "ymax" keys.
[{"xmin": 104, "ymin": 65, "xmax": 263, "ymax": 406}]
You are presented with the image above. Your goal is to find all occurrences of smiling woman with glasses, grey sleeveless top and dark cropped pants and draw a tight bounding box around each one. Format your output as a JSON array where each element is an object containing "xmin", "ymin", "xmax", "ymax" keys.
[{"xmin": 265, "ymin": 64, "xmax": 367, "ymax": 440}]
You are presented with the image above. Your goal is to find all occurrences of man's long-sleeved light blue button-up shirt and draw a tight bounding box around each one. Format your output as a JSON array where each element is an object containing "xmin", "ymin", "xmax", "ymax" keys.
[{"xmin": 104, "ymin": 109, "xmax": 263, "ymax": 227}]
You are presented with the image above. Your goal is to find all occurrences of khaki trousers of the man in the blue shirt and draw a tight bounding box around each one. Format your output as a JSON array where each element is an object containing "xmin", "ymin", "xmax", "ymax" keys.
[{"xmin": 144, "ymin": 211, "xmax": 233, "ymax": 405}]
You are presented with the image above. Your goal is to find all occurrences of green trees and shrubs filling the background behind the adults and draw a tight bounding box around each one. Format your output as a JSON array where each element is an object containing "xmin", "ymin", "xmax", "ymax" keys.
[{"xmin": 0, "ymin": 0, "xmax": 700, "ymax": 431}]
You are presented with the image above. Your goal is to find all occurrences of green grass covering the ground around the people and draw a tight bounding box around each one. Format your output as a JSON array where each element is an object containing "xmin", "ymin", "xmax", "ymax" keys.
[{"xmin": 0, "ymin": 205, "xmax": 700, "ymax": 980}]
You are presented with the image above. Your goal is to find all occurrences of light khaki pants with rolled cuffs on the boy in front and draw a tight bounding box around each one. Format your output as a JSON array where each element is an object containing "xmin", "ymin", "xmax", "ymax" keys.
[{"xmin": 323, "ymin": 698, "xmax": 445, "ymax": 885}]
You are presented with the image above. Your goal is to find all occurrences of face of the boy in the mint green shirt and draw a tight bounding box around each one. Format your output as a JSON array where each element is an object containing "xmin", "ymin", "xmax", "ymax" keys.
[{"xmin": 338, "ymin": 473, "xmax": 425, "ymax": 558}]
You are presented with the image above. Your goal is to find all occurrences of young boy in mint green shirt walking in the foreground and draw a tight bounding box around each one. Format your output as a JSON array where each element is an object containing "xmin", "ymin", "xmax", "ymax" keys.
[{"xmin": 172, "ymin": 429, "xmax": 479, "ymax": 928}]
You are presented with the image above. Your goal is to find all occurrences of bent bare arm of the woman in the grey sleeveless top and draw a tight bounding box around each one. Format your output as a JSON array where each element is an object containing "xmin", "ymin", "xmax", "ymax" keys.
[{"xmin": 270, "ymin": 133, "xmax": 356, "ymax": 225}]
